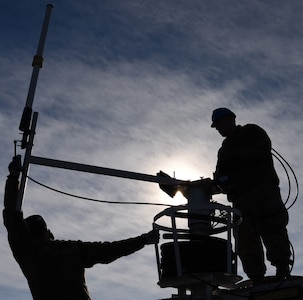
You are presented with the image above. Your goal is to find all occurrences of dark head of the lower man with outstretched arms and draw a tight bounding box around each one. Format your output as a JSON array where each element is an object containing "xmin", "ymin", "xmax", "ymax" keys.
[{"xmin": 24, "ymin": 215, "xmax": 54, "ymax": 240}]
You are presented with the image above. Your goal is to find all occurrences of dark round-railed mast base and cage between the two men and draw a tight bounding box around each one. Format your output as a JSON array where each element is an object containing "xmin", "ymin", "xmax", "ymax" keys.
[{"xmin": 154, "ymin": 172, "xmax": 242, "ymax": 299}]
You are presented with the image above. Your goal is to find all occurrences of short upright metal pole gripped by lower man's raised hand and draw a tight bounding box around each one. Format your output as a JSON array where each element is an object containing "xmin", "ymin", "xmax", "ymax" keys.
[{"xmin": 16, "ymin": 112, "xmax": 38, "ymax": 211}]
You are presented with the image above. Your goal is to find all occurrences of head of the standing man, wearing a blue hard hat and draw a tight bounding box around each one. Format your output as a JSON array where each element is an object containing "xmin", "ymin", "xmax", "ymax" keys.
[{"xmin": 211, "ymin": 107, "xmax": 236, "ymax": 137}]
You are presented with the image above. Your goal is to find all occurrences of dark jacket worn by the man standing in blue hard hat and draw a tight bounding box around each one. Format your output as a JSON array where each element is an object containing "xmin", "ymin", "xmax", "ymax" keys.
[{"xmin": 215, "ymin": 124, "xmax": 279, "ymax": 198}]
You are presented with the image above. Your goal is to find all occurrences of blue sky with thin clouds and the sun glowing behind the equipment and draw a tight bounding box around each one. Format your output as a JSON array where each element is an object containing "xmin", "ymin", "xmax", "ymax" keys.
[{"xmin": 0, "ymin": 0, "xmax": 303, "ymax": 300}]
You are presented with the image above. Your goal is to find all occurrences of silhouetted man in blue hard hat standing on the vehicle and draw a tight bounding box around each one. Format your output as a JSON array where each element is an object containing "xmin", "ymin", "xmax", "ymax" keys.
[{"xmin": 211, "ymin": 108, "xmax": 291, "ymax": 284}]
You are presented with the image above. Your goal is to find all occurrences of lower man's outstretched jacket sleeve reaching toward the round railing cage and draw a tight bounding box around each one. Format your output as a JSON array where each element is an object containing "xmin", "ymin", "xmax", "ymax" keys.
[{"xmin": 83, "ymin": 236, "xmax": 146, "ymax": 267}]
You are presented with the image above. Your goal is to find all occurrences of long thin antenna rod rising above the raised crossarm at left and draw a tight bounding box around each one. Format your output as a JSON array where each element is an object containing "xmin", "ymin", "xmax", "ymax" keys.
[{"xmin": 19, "ymin": 4, "xmax": 53, "ymax": 149}]
